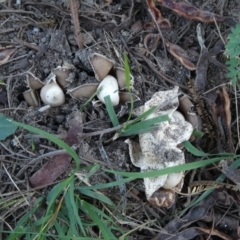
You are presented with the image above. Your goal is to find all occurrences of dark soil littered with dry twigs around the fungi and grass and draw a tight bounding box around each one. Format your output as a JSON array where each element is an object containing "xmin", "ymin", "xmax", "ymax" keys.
[{"xmin": 0, "ymin": 0, "xmax": 240, "ymax": 239}]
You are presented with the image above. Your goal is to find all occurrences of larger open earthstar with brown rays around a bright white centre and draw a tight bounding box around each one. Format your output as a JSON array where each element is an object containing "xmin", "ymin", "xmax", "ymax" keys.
[{"xmin": 67, "ymin": 53, "xmax": 139, "ymax": 106}]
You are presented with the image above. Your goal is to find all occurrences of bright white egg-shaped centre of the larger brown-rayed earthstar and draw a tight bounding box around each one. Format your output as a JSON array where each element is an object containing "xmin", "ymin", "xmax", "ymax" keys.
[{"xmin": 97, "ymin": 75, "xmax": 119, "ymax": 106}]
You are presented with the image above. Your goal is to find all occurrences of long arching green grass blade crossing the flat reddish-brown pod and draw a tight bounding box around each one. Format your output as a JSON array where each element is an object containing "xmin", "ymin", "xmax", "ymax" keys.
[{"xmin": 8, "ymin": 119, "xmax": 80, "ymax": 169}]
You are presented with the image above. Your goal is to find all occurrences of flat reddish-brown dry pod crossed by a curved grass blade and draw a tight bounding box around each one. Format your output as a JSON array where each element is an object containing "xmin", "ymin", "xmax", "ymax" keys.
[{"xmin": 29, "ymin": 111, "xmax": 82, "ymax": 188}]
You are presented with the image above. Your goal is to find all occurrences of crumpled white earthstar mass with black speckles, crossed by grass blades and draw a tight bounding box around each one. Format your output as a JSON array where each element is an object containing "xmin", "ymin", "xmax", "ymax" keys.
[{"xmin": 126, "ymin": 87, "xmax": 193, "ymax": 207}]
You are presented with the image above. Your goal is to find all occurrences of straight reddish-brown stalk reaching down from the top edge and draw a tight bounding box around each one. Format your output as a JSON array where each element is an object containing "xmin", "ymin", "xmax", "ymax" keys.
[{"xmin": 70, "ymin": 0, "xmax": 84, "ymax": 49}]
